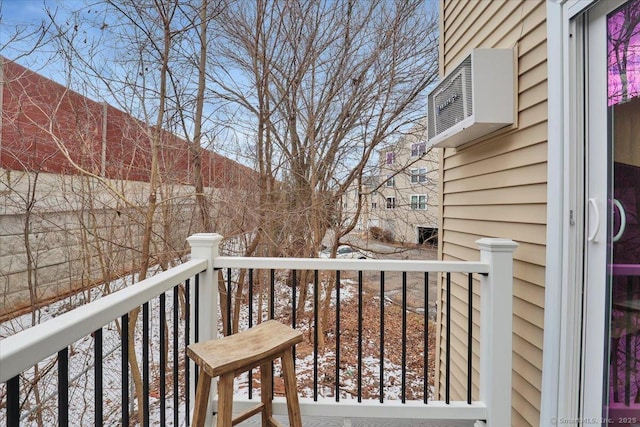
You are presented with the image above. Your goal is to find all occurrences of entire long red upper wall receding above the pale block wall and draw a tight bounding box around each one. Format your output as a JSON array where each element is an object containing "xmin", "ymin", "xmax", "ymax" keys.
[{"xmin": 0, "ymin": 57, "xmax": 255, "ymax": 189}]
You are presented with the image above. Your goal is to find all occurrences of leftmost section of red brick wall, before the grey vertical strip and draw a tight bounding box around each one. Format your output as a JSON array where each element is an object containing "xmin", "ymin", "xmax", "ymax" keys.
[{"xmin": 0, "ymin": 61, "xmax": 102, "ymax": 173}]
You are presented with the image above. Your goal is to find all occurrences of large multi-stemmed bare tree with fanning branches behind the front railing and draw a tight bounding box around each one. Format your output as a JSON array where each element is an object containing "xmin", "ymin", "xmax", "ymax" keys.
[{"xmin": 212, "ymin": 0, "xmax": 437, "ymax": 340}]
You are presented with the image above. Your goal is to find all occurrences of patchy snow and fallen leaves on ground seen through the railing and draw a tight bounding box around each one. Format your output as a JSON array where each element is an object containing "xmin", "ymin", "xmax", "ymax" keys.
[{"xmin": 0, "ymin": 268, "xmax": 432, "ymax": 426}]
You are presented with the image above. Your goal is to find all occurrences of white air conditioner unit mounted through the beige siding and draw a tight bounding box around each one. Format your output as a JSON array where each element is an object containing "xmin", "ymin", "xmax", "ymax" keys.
[{"xmin": 428, "ymin": 49, "xmax": 514, "ymax": 147}]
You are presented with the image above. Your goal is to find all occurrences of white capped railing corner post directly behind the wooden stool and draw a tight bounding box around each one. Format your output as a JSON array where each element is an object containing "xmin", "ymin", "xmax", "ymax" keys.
[{"xmin": 187, "ymin": 233, "xmax": 222, "ymax": 425}]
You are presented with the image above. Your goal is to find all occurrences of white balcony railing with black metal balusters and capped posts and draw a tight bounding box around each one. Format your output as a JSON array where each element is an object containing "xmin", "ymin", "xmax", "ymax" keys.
[{"xmin": 0, "ymin": 234, "xmax": 517, "ymax": 426}]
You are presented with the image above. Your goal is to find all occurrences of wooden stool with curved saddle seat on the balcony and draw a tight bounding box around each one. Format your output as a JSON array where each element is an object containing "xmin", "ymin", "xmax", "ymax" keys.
[{"xmin": 187, "ymin": 320, "xmax": 302, "ymax": 427}]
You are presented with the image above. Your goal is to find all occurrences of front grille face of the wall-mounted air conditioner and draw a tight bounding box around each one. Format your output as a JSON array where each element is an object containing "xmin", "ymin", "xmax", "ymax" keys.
[{"xmin": 429, "ymin": 56, "xmax": 473, "ymax": 138}]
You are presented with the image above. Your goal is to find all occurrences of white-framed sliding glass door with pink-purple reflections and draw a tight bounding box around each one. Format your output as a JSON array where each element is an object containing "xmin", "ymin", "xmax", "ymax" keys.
[{"xmin": 582, "ymin": 0, "xmax": 640, "ymax": 426}]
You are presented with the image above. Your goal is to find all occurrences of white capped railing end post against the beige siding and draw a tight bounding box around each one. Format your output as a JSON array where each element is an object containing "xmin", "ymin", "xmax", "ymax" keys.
[{"xmin": 476, "ymin": 238, "xmax": 518, "ymax": 427}]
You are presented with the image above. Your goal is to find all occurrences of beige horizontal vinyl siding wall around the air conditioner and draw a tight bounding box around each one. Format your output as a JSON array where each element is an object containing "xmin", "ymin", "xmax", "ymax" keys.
[{"xmin": 436, "ymin": 0, "xmax": 547, "ymax": 426}]
